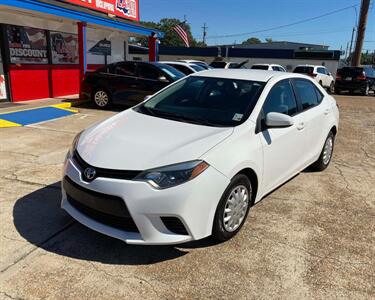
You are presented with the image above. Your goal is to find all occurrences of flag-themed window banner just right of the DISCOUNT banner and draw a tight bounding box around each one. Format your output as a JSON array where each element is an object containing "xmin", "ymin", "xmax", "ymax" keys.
[{"xmin": 50, "ymin": 31, "xmax": 78, "ymax": 64}]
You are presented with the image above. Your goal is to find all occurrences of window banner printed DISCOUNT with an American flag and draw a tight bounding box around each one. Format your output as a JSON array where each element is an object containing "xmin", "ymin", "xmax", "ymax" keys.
[{"xmin": 7, "ymin": 25, "xmax": 48, "ymax": 64}]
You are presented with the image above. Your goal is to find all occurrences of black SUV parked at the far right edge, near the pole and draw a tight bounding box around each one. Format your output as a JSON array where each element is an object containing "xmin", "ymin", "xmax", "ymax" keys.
[{"xmin": 335, "ymin": 67, "xmax": 375, "ymax": 95}]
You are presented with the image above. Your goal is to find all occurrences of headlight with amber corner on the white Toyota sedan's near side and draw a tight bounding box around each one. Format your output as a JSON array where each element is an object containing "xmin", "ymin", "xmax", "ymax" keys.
[{"xmin": 135, "ymin": 160, "xmax": 209, "ymax": 189}]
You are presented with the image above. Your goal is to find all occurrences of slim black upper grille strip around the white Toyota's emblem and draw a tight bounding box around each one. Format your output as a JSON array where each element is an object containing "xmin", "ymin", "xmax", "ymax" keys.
[{"xmin": 73, "ymin": 150, "xmax": 142, "ymax": 180}]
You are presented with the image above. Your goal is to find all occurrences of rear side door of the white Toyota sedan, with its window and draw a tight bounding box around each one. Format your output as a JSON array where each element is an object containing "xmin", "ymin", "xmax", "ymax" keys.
[{"xmin": 292, "ymin": 78, "xmax": 332, "ymax": 163}]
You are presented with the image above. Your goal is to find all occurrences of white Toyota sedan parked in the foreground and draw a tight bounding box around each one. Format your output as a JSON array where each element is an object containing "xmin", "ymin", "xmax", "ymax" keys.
[{"xmin": 62, "ymin": 70, "xmax": 339, "ymax": 244}]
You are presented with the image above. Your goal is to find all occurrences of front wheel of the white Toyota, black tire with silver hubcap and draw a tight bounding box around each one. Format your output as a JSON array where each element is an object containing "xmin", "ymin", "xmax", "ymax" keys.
[{"xmin": 212, "ymin": 174, "xmax": 253, "ymax": 242}]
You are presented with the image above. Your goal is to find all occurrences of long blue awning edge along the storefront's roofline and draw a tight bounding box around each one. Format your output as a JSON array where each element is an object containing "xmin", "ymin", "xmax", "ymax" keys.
[{"xmin": 0, "ymin": 0, "xmax": 164, "ymax": 38}]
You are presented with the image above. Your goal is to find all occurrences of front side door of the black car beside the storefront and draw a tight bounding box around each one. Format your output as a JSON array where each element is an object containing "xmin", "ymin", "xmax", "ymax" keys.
[{"xmin": 137, "ymin": 63, "xmax": 172, "ymax": 101}]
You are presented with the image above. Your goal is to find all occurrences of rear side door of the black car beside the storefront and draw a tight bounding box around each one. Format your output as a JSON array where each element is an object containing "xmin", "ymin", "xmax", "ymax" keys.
[{"xmin": 111, "ymin": 62, "xmax": 137, "ymax": 105}]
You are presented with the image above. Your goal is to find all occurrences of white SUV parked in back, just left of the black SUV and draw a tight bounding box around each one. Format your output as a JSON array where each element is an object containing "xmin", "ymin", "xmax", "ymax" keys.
[{"xmin": 293, "ymin": 65, "xmax": 335, "ymax": 93}]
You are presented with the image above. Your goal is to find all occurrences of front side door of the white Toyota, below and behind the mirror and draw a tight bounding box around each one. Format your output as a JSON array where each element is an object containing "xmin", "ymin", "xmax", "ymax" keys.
[{"xmin": 258, "ymin": 79, "xmax": 306, "ymax": 192}]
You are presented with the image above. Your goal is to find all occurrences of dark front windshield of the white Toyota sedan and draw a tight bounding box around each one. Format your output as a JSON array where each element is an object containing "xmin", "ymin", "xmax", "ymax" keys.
[{"xmin": 134, "ymin": 76, "xmax": 265, "ymax": 127}]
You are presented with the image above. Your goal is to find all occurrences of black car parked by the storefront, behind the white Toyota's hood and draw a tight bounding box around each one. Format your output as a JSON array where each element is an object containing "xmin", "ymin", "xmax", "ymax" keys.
[{"xmin": 80, "ymin": 61, "xmax": 185, "ymax": 108}]
